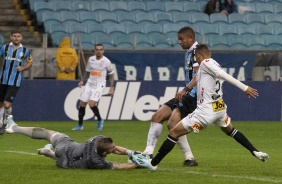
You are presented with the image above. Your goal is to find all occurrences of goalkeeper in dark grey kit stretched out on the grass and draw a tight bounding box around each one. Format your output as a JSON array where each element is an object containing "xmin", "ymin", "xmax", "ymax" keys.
[{"xmin": 6, "ymin": 115, "xmax": 149, "ymax": 169}]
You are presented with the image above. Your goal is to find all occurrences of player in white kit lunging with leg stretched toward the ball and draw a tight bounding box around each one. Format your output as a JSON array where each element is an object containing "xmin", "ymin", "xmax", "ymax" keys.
[{"xmin": 141, "ymin": 44, "xmax": 269, "ymax": 170}]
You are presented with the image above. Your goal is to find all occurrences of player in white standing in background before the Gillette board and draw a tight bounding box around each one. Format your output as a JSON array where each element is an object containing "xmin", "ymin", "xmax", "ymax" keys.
[{"xmin": 72, "ymin": 44, "xmax": 114, "ymax": 130}]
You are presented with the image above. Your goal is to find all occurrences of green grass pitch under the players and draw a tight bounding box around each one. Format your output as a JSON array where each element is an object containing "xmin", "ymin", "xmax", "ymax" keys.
[{"xmin": 0, "ymin": 121, "xmax": 282, "ymax": 184}]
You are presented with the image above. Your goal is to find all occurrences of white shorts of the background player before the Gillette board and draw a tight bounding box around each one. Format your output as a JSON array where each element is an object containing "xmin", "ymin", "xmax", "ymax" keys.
[{"xmin": 79, "ymin": 80, "xmax": 106, "ymax": 102}]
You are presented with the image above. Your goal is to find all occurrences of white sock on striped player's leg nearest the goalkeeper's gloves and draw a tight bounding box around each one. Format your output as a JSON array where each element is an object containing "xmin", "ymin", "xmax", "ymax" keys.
[{"xmin": 144, "ymin": 122, "xmax": 163, "ymax": 154}]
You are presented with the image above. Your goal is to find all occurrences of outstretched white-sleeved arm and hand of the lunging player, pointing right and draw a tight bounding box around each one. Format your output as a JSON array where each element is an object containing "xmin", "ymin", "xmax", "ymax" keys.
[{"xmin": 218, "ymin": 70, "xmax": 258, "ymax": 98}]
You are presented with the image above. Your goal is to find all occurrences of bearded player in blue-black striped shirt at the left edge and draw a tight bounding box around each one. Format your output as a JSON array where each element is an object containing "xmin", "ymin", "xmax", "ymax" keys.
[{"xmin": 0, "ymin": 30, "xmax": 32, "ymax": 134}]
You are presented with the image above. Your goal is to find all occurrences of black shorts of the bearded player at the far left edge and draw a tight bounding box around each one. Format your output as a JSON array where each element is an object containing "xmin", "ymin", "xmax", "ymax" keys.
[{"xmin": 0, "ymin": 84, "xmax": 20, "ymax": 103}]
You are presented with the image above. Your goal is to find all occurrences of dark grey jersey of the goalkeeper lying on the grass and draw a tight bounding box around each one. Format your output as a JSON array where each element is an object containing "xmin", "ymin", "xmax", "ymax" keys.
[{"xmin": 56, "ymin": 136, "xmax": 113, "ymax": 169}]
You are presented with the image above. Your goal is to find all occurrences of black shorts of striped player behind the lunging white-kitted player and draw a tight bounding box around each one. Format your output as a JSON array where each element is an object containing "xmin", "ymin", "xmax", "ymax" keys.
[{"xmin": 165, "ymin": 94, "xmax": 197, "ymax": 119}]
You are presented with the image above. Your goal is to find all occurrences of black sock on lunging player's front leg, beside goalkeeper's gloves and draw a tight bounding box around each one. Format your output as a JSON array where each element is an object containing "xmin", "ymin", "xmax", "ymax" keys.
[{"xmin": 151, "ymin": 135, "xmax": 177, "ymax": 166}]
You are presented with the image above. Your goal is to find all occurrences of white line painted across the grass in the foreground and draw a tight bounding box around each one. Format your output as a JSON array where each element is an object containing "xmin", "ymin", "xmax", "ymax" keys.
[{"xmin": 0, "ymin": 151, "xmax": 282, "ymax": 183}]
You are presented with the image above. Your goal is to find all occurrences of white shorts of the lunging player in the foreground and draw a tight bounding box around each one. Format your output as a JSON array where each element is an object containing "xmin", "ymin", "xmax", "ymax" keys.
[{"xmin": 181, "ymin": 109, "xmax": 231, "ymax": 133}]
